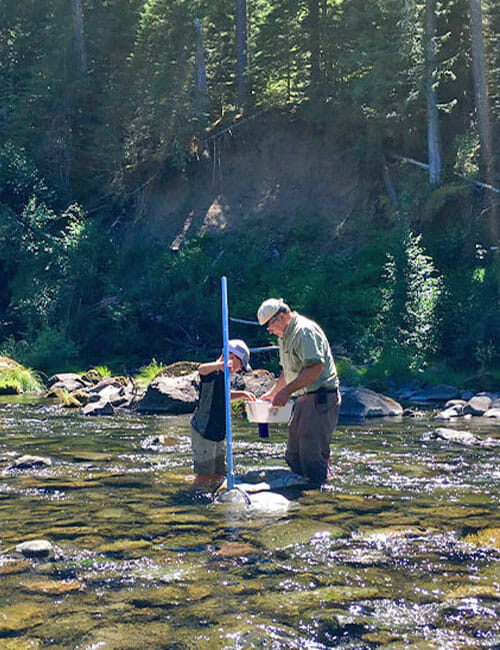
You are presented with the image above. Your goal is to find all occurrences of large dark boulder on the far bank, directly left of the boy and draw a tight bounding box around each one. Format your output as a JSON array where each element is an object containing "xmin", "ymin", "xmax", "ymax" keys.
[{"xmin": 137, "ymin": 372, "xmax": 199, "ymax": 415}]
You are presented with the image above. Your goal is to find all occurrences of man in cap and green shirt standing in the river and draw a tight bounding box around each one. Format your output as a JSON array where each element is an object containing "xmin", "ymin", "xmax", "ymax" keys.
[{"xmin": 257, "ymin": 298, "xmax": 341, "ymax": 487}]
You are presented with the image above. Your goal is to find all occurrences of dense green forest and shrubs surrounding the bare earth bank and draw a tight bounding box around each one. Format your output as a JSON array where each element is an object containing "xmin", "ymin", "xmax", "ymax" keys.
[{"xmin": 0, "ymin": 0, "xmax": 500, "ymax": 378}]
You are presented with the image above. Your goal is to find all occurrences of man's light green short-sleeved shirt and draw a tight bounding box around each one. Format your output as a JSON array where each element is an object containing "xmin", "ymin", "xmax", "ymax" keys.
[{"xmin": 279, "ymin": 313, "xmax": 339, "ymax": 396}]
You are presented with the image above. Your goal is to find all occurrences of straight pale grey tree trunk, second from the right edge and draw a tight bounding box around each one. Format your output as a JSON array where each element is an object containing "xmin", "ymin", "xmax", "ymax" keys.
[{"xmin": 425, "ymin": 0, "xmax": 441, "ymax": 187}]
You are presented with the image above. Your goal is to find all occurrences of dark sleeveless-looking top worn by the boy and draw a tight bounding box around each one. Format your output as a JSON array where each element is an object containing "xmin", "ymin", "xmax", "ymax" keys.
[{"xmin": 191, "ymin": 371, "xmax": 226, "ymax": 442}]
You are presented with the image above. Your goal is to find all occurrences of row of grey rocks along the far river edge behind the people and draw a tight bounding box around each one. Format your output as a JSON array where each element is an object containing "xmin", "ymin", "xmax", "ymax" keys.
[{"xmin": 46, "ymin": 362, "xmax": 500, "ymax": 421}]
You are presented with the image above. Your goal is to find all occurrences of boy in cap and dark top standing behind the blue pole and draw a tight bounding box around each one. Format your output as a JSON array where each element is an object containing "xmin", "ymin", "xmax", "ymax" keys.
[{"xmin": 191, "ymin": 339, "xmax": 256, "ymax": 487}]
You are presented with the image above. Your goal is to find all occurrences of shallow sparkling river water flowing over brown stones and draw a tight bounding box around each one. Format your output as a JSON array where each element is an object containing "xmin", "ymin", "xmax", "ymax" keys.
[{"xmin": 0, "ymin": 398, "xmax": 500, "ymax": 650}]
